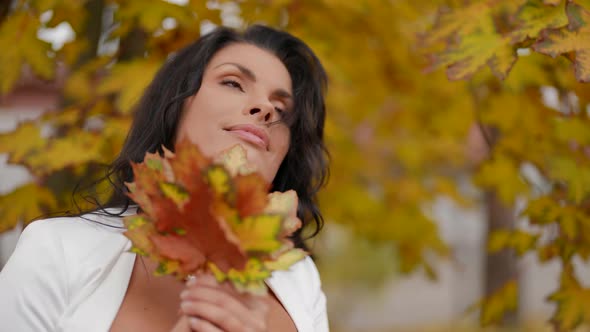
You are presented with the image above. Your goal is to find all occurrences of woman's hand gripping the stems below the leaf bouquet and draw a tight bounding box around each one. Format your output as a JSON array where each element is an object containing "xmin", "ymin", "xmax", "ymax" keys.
[{"xmin": 179, "ymin": 275, "xmax": 269, "ymax": 332}]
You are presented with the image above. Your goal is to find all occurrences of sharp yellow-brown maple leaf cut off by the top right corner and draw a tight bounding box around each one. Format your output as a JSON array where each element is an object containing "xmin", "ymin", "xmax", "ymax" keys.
[{"xmin": 533, "ymin": 1, "xmax": 590, "ymax": 82}]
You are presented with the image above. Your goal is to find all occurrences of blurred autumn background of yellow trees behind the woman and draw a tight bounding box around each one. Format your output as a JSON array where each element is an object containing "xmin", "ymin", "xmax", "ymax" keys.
[{"xmin": 0, "ymin": 0, "xmax": 590, "ymax": 332}]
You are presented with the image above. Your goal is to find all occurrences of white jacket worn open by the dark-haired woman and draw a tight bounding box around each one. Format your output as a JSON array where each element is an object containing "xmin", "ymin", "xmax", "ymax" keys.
[{"xmin": 0, "ymin": 211, "xmax": 328, "ymax": 332}]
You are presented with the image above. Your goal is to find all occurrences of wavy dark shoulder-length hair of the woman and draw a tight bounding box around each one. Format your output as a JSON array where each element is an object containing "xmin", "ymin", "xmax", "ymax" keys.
[{"xmin": 85, "ymin": 25, "xmax": 328, "ymax": 247}]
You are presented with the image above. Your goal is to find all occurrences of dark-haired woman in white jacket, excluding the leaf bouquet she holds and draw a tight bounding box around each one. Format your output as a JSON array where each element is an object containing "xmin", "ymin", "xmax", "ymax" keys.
[{"xmin": 0, "ymin": 26, "xmax": 328, "ymax": 331}]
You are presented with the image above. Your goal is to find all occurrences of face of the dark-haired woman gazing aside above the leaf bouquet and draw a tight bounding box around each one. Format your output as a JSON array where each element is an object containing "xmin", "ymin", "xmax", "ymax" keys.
[{"xmin": 177, "ymin": 43, "xmax": 293, "ymax": 182}]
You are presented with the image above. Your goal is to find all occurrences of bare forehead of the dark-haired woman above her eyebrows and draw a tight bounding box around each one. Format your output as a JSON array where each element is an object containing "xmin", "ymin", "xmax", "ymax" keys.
[{"xmin": 206, "ymin": 43, "xmax": 292, "ymax": 91}]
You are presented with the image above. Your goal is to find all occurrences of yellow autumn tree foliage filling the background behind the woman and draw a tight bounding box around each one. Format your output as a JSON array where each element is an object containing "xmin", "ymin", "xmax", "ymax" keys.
[{"xmin": 0, "ymin": 0, "xmax": 590, "ymax": 326}]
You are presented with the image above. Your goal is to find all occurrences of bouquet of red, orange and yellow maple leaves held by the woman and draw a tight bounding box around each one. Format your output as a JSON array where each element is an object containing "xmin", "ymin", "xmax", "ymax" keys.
[{"xmin": 124, "ymin": 140, "xmax": 307, "ymax": 294}]
